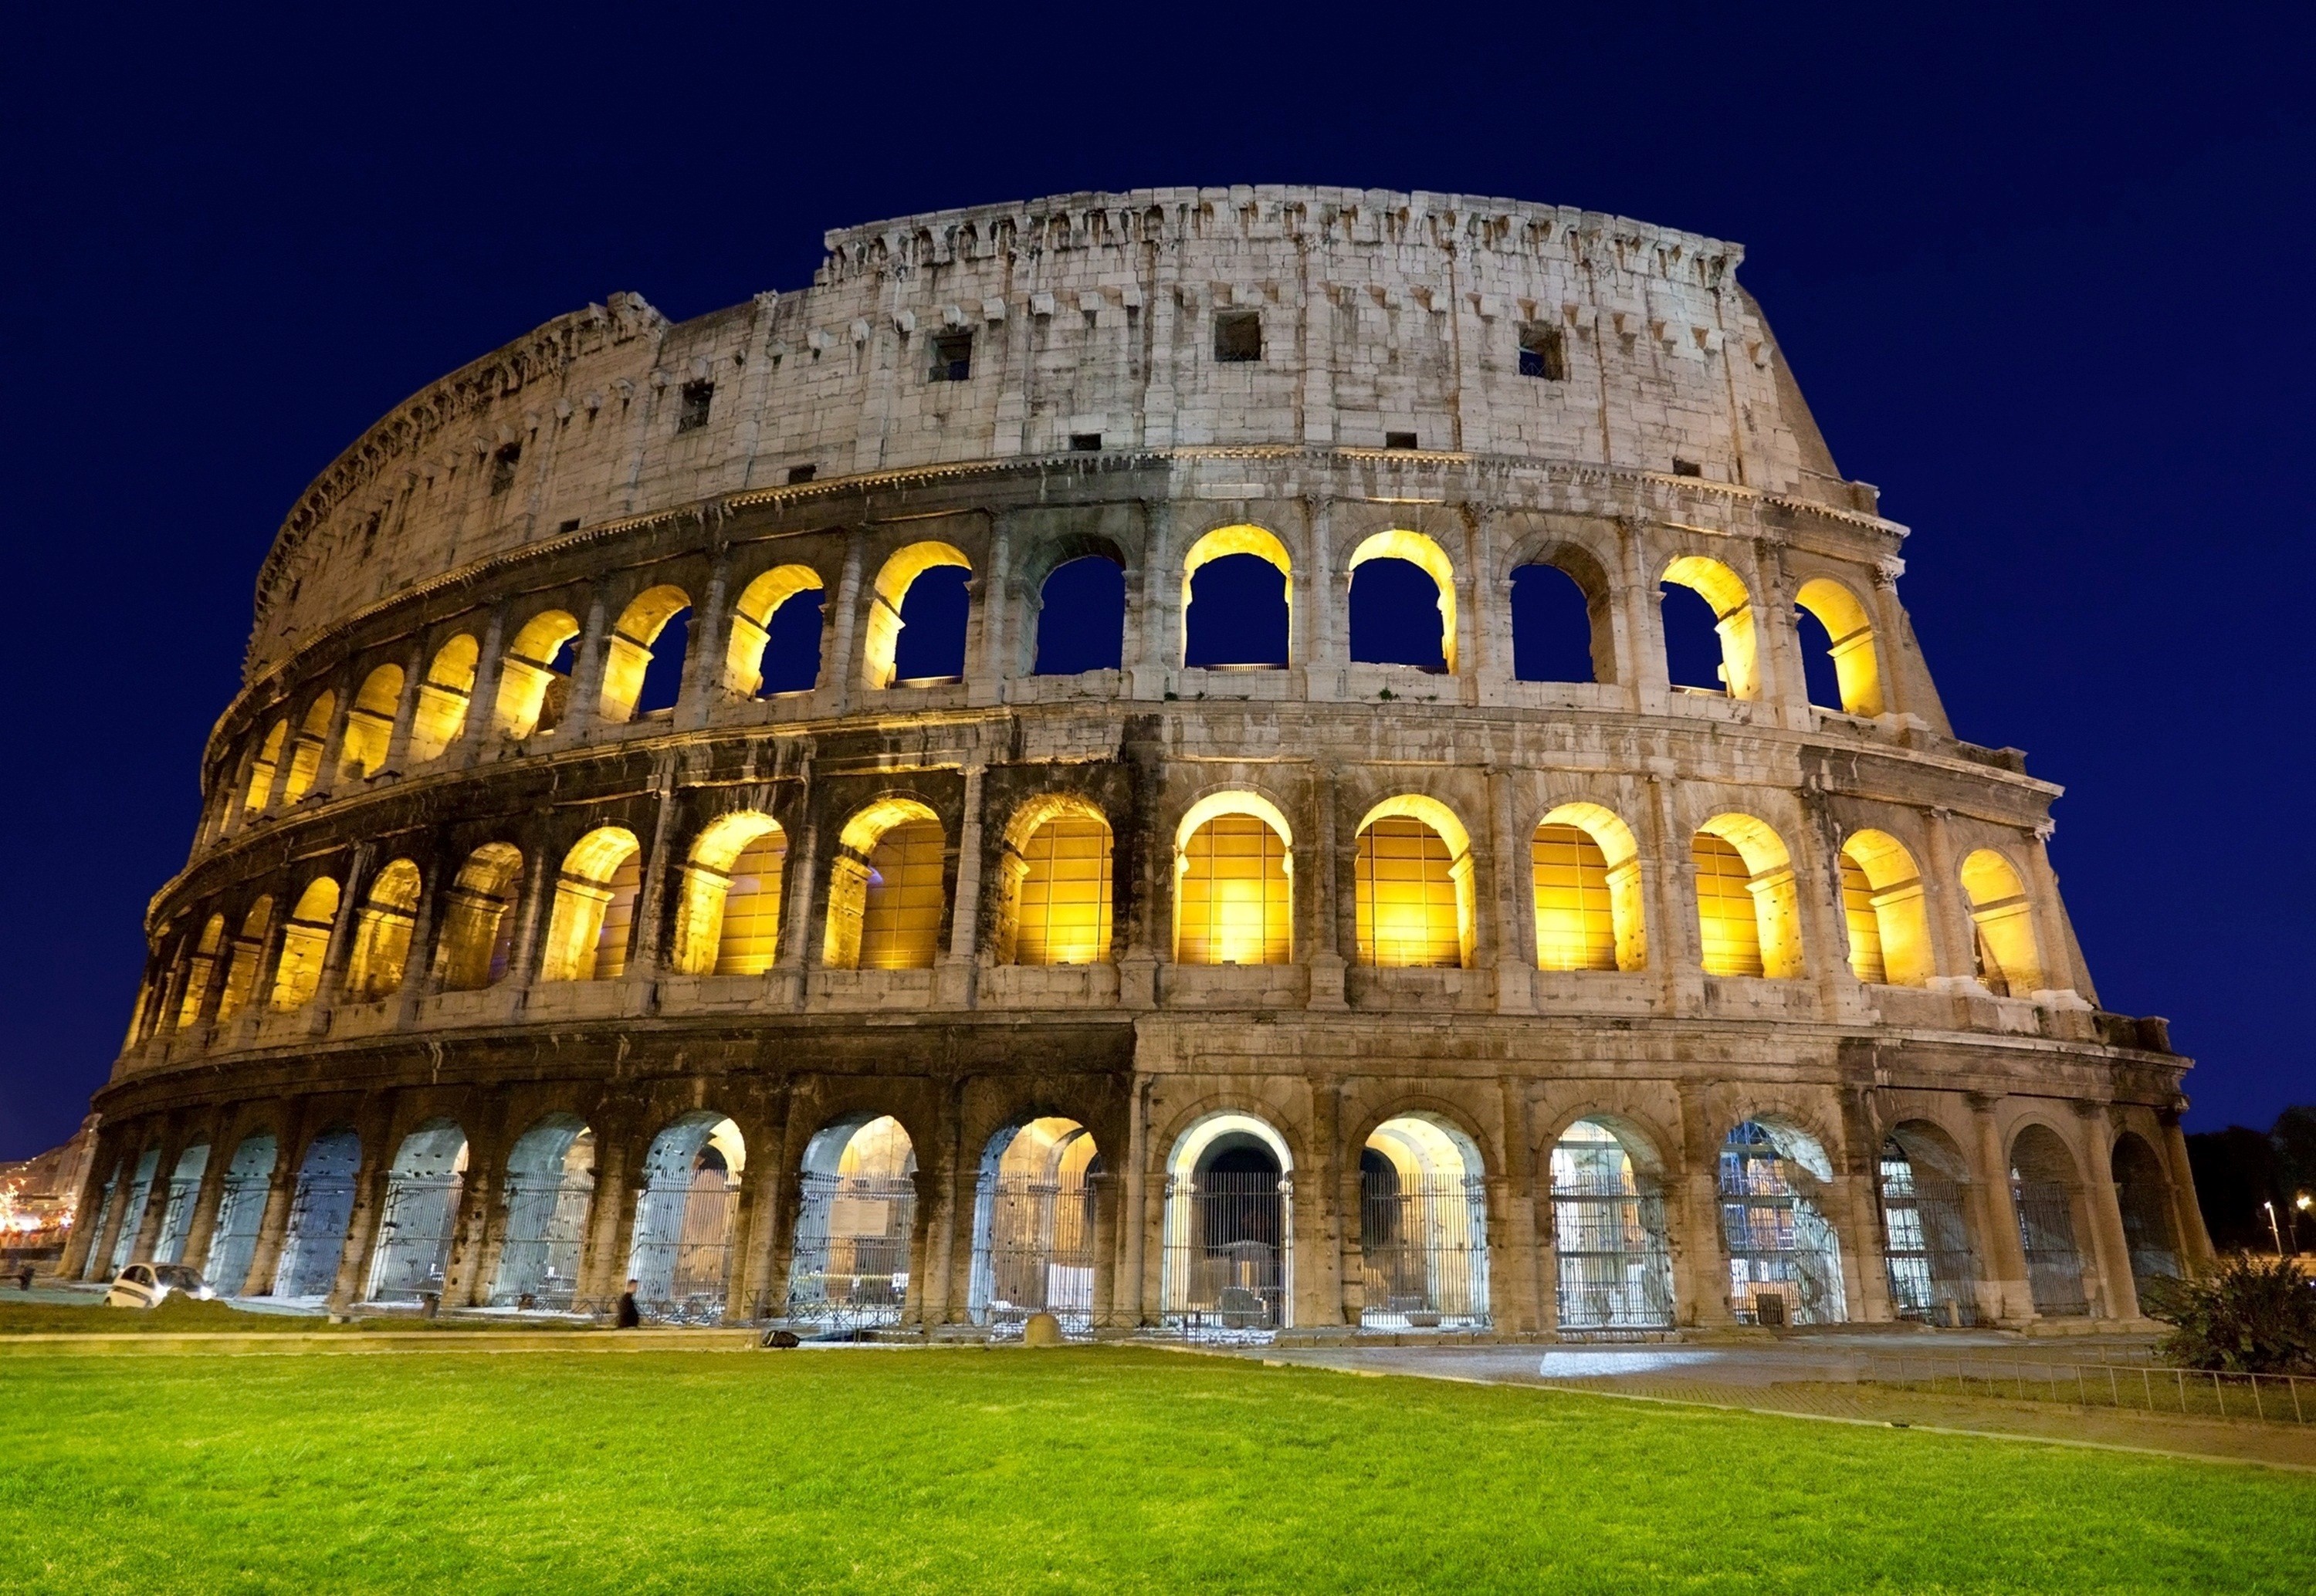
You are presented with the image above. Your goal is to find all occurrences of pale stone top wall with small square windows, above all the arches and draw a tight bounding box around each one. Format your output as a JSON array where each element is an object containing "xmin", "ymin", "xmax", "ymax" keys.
[{"xmin": 248, "ymin": 188, "xmax": 1874, "ymax": 678}]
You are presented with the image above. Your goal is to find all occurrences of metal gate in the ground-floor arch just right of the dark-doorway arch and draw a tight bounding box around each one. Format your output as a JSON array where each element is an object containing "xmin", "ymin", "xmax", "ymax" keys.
[{"xmin": 1359, "ymin": 1170, "xmax": 1487, "ymax": 1330}]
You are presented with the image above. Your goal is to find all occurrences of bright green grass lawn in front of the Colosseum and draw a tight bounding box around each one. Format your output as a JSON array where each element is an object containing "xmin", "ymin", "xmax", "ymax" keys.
[{"xmin": 0, "ymin": 1348, "xmax": 2316, "ymax": 1594}]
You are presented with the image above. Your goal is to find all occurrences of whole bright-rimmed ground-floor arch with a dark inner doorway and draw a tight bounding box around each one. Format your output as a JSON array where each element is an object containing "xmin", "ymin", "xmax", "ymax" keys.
[{"xmin": 1158, "ymin": 1112, "xmax": 1295, "ymax": 1339}]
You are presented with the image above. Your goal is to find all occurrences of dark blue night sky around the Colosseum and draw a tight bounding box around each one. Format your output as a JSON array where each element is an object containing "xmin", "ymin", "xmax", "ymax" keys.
[{"xmin": 0, "ymin": 5, "xmax": 2316, "ymax": 1158}]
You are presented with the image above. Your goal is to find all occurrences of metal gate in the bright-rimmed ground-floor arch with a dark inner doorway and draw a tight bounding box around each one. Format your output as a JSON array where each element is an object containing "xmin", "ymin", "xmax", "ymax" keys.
[{"xmin": 1163, "ymin": 1170, "xmax": 1295, "ymax": 1337}]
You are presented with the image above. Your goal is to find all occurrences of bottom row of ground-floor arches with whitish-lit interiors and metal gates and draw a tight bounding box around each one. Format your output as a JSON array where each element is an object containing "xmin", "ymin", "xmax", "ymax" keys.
[{"xmin": 83, "ymin": 1093, "xmax": 2184, "ymax": 1334}]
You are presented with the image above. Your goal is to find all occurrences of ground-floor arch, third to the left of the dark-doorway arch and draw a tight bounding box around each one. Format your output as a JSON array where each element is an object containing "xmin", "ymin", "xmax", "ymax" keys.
[{"xmin": 628, "ymin": 1110, "xmax": 748, "ymax": 1325}]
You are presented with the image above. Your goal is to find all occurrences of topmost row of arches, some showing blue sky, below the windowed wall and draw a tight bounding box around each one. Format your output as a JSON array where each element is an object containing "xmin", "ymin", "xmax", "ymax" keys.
[{"xmin": 208, "ymin": 526, "xmax": 1885, "ymax": 834}]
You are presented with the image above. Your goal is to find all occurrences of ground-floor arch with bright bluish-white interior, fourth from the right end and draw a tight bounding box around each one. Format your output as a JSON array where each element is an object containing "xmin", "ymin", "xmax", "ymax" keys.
[{"xmin": 1721, "ymin": 1119, "xmax": 1848, "ymax": 1325}]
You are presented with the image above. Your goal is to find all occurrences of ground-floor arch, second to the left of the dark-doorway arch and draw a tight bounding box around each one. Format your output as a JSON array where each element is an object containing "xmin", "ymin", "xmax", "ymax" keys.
[{"xmin": 787, "ymin": 1114, "xmax": 917, "ymax": 1330}]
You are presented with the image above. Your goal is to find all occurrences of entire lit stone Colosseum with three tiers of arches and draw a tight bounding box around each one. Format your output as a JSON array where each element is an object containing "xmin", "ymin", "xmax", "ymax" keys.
[{"xmin": 67, "ymin": 188, "xmax": 2209, "ymax": 1339}]
